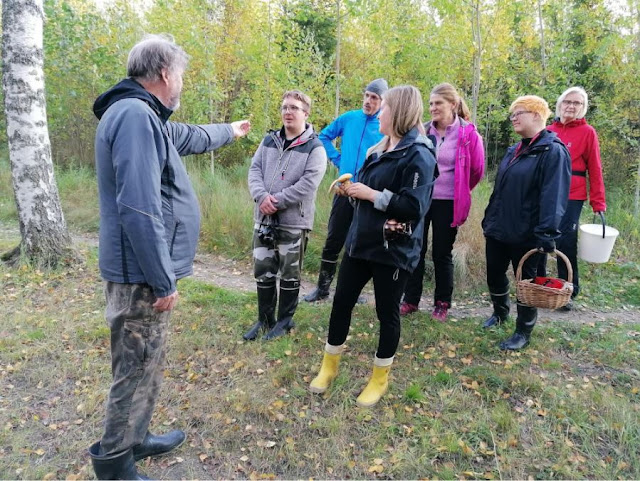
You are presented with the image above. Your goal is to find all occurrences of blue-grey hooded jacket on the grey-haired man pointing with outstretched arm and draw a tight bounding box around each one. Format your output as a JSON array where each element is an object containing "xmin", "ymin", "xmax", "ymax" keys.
[{"xmin": 93, "ymin": 79, "xmax": 233, "ymax": 297}]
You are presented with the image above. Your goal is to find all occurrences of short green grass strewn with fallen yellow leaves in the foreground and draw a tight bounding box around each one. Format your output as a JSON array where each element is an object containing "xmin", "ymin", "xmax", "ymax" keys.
[{"xmin": 0, "ymin": 256, "xmax": 640, "ymax": 479}]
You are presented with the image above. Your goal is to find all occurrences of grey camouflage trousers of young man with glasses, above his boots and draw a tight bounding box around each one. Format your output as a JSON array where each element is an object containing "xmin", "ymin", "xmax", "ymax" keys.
[{"xmin": 253, "ymin": 226, "xmax": 307, "ymax": 285}]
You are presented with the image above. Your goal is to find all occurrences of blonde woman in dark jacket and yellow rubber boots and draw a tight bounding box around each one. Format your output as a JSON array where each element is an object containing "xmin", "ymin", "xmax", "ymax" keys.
[{"xmin": 310, "ymin": 85, "xmax": 436, "ymax": 406}]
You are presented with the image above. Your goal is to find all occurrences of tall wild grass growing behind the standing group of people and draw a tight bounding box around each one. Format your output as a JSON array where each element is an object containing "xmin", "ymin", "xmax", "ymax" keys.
[{"xmin": 0, "ymin": 157, "xmax": 640, "ymax": 304}]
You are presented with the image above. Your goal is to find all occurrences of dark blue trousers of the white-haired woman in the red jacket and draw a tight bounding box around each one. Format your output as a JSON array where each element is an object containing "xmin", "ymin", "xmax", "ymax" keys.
[{"xmin": 538, "ymin": 200, "xmax": 584, "ymax": 297}]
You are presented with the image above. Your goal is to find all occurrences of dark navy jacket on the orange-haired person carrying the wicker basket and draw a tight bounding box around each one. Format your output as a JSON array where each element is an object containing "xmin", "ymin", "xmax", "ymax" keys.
[{"xmin": 482, "ymin": 130, "xmax": 571, "ymax": 247}]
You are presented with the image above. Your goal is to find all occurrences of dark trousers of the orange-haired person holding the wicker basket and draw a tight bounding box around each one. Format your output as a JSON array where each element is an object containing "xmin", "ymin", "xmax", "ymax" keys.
[{"xmin": 485, "ymin": 237, "xmax": 541, "ymax": 294}]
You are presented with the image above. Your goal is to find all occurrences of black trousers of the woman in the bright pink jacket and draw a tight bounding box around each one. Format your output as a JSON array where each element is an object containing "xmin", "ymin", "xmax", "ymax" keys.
[{"xmin": 404, "ymin": 200, "xmax": 458, "ymax": 306}]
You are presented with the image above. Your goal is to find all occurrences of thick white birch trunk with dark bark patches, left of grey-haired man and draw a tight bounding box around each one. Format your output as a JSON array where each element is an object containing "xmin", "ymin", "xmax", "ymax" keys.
[{"xmin": 2, "ymin": 0, "xmax": 71, "ymax": 267}]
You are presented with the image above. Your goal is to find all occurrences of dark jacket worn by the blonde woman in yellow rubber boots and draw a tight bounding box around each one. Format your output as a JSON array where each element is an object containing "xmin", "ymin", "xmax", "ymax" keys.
[{"xmin": 346, "ymin": 129, "xmax": 436, "ymax": 272}]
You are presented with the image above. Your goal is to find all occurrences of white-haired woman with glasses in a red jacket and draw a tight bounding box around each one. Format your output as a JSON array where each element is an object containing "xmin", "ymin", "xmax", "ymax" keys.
[{"xmin": 538, "ymin": 87, "xmax": 607, "ymax": 311}]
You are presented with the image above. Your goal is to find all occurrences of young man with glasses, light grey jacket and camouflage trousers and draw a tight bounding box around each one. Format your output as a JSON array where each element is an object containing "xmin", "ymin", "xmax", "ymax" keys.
[{"xmin": 242, "ymin": 90, "xmax": 327, "ymax": 341}]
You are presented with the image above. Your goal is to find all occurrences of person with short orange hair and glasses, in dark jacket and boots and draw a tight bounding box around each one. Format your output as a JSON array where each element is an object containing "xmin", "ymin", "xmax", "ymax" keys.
[{"xmin": 482, "ymin": 95, "xmax": 571, "ymax": 350}]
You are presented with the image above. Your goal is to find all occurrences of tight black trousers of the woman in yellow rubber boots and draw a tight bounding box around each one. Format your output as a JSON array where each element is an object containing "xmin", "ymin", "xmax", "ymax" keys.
[{"xmin": 328, "ymin": 254, "xmax": 409, "ymax": 359}]
